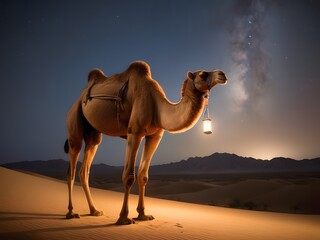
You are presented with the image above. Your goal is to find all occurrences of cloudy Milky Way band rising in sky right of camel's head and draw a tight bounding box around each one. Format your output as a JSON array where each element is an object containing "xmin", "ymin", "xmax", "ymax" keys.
[{"xmin": 230, "ymin": 0, "xmax": 269, "ymax": 112}]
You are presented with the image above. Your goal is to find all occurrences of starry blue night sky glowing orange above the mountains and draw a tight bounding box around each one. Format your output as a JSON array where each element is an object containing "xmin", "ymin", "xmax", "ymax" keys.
[{"xmin": 0, "ymin": 0, "xmax": 320, "ymax": 165}]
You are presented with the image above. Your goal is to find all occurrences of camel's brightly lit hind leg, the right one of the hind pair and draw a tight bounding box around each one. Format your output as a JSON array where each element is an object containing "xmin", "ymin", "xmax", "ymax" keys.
[{"xmin": 79, "ymin": 129, "xmax": 103, "ymax": 216}]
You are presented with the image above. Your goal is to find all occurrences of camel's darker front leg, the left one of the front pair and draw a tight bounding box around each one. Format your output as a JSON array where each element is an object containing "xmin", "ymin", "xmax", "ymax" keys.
[{"xmin": 117, "ymin": 134, "xmax": 142, "ymax": 225}]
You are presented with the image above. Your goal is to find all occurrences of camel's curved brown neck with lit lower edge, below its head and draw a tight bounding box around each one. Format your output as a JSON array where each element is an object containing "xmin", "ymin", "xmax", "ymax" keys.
[{"xmin": 158, "ymin": 80, "xmax": 205, "ymax": 133}]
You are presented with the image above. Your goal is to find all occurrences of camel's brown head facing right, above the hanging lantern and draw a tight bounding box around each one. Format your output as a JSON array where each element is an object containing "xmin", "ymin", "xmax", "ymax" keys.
[{"xmin": 188, "ymin": 70, "xmax": 227, "ymax": 92}]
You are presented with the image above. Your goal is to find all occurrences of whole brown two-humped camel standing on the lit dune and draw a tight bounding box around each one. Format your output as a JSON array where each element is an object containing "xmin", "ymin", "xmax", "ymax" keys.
[{"xmin": 65, "ymin": 61, "xmax": 227, "ymax": 225}]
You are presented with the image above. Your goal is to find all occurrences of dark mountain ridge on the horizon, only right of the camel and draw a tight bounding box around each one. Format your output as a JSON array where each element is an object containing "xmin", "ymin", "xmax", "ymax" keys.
[{"xmin": 150, "ymin": 153, "xmax": 320, "ymax": 174}]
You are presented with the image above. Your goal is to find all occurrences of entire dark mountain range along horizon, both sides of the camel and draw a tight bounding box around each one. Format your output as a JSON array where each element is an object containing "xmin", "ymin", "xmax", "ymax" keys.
[{"xmin": 2, "ymin": 153, "xmax": 320, "ymax": 179}]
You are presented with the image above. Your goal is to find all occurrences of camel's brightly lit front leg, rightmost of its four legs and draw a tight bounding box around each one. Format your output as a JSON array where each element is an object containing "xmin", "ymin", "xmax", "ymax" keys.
[{"xmin": 135, "ymin": 130, "xmax": 163, "ymax": 221}]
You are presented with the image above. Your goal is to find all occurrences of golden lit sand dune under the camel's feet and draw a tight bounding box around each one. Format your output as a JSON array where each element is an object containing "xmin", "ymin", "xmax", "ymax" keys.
[{"xmin": 0, "ymin": 168, "xmax": 320, "ymax": 240}]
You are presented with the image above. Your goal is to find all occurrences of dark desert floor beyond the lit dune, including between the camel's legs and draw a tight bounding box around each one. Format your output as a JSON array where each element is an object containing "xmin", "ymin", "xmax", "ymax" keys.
[{"xmin": 91, "ymin": 173, "xmax": 320, "ymax": 215}]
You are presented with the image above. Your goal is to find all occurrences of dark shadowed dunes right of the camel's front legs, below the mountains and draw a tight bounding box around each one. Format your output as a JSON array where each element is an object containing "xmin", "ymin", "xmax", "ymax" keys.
[{"xmin": 132, "ymin": 177, "xmax": 320, "ymax": 214}]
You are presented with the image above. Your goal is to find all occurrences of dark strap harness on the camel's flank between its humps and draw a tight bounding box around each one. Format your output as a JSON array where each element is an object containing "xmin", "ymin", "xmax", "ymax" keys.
[{"xmin": 83, "ymin": 79, "xmax": 129, "ymax": 125}]
